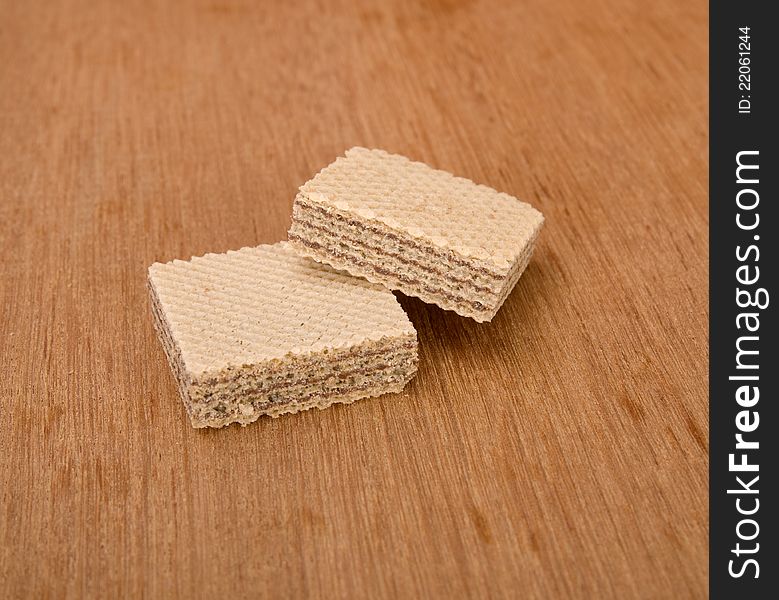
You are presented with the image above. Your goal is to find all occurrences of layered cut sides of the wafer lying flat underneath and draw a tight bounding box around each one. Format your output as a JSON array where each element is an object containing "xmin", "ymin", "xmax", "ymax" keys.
[{"xmin": 148, "ymin": 280, "xmax": 418, "ymax": 428}]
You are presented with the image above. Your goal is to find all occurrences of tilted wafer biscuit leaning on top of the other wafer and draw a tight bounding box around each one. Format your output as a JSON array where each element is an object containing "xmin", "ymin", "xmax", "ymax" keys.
[{"xmin": 289, "ymin": 148, "xmax": 544, "ymax": 321}]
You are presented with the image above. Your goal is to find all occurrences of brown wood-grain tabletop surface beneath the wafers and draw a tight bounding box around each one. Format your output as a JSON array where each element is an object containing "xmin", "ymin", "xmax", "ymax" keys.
[{"xmin": 0, "ymin": 0, "xmax": 708, "ymax": 598}]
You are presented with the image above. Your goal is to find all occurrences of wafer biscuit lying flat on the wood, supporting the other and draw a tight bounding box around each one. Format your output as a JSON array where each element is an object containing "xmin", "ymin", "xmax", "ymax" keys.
[{"xmin": 148, "ymin": 242, "xmax": 417, "ymax": 427}]
